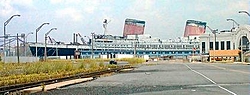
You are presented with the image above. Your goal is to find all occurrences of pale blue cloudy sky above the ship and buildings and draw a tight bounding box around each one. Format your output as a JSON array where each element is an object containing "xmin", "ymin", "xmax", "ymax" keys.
[{"xmin": 0, "ymin": 0, "xmax": 250, "ymax": 43}]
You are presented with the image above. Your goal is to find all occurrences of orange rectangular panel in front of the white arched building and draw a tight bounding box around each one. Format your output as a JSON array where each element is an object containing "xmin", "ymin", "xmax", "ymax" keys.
[{"xmin": 209, "ymin": 49, "xmax": 240, "ymax": 57}]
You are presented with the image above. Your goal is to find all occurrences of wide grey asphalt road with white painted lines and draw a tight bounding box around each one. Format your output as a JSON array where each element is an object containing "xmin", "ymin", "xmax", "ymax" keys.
[{"xmin": 35, "ymin": 61, "xmax": 250, "ymax": 95}]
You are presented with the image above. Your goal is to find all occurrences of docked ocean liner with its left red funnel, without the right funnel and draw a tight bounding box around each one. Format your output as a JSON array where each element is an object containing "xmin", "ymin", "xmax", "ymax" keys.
[{"xmin": 29, "ymin": 19, "xmax": 200, "ymax": 59}]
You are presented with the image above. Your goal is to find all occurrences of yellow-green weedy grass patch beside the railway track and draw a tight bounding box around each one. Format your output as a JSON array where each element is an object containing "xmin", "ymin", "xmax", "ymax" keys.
[{"xmin": 0, "ymin": 58, "xmax": 145, "ymax": 86}]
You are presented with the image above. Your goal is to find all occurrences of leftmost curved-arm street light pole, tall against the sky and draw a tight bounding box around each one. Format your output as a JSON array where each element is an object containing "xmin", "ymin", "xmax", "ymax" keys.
[{"xmin": 3, "ymin": 14, "xmax": 21, "ymax": 63}]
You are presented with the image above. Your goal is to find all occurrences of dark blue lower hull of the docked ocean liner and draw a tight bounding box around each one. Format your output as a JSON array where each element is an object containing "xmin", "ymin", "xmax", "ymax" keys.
[{"xmin": 30, "ymin": 45, "xmax": 199, "ymax": 58}]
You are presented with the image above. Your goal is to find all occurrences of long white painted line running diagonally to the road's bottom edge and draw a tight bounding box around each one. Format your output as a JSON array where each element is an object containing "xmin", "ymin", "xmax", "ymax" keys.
[{"xmin": 185, "ymin": 64, "xmax": 237, "ymax": 95}]
